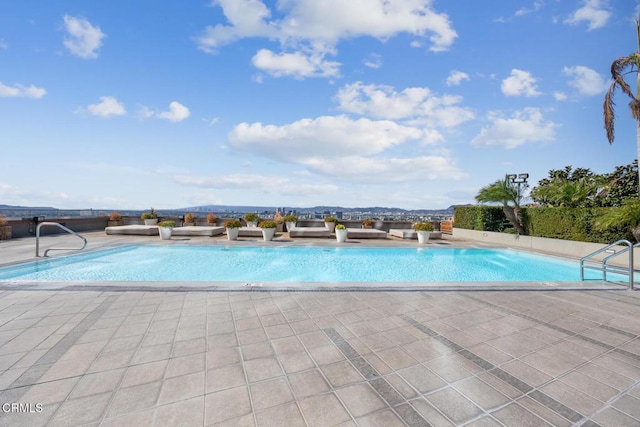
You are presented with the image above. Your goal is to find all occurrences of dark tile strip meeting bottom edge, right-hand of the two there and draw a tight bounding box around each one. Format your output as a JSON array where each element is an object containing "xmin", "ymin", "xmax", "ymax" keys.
[{"xmin": 400, "ymin": 315, "xmax": 586, "ymax": 423}]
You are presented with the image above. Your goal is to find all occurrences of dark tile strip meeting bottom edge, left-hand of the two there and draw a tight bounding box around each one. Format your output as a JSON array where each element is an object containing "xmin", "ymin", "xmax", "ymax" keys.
[{"xmin": 323, "ymin": 328, "xmax": 431, "ymax": 427}]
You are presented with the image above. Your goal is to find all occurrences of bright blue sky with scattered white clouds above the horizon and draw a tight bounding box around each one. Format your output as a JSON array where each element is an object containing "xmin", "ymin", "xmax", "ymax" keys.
[{"xmin": 0, "ymin": 0, "xmax": 640, "ymax": 209}]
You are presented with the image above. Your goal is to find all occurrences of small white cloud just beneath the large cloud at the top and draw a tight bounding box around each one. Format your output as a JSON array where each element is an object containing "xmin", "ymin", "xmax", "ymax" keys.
[{"xmin": 251, "ymin": 49, "xmax": 340, "ymax": 78}]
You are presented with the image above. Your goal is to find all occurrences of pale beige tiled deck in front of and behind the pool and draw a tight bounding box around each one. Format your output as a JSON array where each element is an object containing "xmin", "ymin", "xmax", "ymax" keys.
[{"xmin": 0, "ymin": 233, "xmax": 640, "ymax": 426}]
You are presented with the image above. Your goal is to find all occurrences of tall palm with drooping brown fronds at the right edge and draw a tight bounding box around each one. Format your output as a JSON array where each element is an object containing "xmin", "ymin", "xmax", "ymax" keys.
[{"xmin": 603, "ymin": 18, "xmax": 640, "ymax": 193}]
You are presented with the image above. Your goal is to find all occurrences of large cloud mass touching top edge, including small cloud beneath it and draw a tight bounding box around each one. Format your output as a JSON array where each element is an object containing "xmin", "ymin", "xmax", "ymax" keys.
[{"xmin": 195, "ymin": 0, "xmax": 458, "ymax": 78}]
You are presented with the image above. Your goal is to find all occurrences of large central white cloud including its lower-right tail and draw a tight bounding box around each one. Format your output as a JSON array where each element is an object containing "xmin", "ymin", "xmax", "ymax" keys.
[{"xmin": 229, "ymin": 116, "xmax": 464, "ymax": 184}]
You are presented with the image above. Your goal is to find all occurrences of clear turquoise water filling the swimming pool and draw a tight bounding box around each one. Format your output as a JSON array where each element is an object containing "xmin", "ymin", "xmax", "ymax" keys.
[{"xmin": 0, "ymin": 246, "xmax": 624, "ymax": 282}]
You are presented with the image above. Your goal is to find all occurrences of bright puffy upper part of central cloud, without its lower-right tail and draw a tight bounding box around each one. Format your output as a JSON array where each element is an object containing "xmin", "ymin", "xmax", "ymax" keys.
[{"xmin": 229, "ymin": 116, "xmax": 424, "ymax": 163}]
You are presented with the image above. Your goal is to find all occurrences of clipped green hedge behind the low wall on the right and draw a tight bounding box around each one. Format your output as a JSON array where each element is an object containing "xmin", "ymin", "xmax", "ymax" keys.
[{"xmin": 454, "ymin": 206, "xmax": 633, "ymax": 243}]
